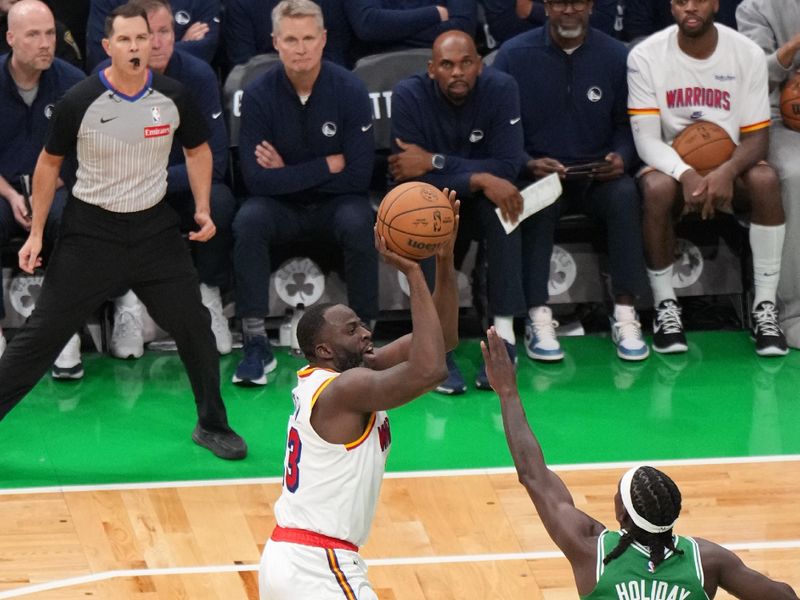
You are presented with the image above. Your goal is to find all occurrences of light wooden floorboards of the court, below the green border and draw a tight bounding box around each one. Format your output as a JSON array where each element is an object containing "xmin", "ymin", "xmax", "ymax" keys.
[{"xmin": 0, "ymin": 460, "xmax": 800, "ymax": 600}]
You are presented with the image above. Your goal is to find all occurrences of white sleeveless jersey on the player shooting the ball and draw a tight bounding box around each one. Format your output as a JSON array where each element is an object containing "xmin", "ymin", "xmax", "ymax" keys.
[{"xmin": 275, "ymin": 367, "xmax": 391, "ymax": 546}]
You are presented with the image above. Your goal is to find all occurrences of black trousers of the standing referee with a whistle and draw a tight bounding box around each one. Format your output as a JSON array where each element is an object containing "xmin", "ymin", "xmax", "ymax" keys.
[{"xmin": 0, "ymin": 198, "xmax": 230, "ymax": 431}]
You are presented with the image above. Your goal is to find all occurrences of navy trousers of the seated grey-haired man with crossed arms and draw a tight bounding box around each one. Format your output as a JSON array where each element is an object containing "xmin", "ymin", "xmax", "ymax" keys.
[{"xmin": 233, "ymin": 195, "xmax": 378, "ymax": 323}]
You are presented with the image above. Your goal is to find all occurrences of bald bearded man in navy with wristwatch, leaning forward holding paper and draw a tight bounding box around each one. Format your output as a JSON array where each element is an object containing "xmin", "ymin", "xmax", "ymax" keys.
[{"xmin": 389, "ymin": 31, "xmax": 527, "ymax": 394}]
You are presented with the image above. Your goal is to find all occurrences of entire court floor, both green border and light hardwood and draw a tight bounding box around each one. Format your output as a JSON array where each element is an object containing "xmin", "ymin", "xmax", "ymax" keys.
[{"xmin": 0, "ymin": 332, "xmax": 800, "ymax": 600}]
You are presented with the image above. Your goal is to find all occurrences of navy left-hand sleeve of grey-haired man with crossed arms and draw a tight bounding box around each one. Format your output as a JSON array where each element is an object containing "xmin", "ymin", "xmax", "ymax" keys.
[{"xmin": 239, "ymin": 88, "xmax": 332, "ymax": 196}]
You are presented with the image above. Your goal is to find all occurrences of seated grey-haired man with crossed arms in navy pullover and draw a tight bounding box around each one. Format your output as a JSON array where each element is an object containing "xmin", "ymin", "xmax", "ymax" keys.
[{"xmin": 233, "ymin": 0, "xmax": 378, "ymax": 385}]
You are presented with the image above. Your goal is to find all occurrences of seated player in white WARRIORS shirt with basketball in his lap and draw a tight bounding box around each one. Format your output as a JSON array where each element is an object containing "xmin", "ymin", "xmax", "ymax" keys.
[{"xmin": 628, "ymin": 0, "xmax": 788, "ymax": 356}]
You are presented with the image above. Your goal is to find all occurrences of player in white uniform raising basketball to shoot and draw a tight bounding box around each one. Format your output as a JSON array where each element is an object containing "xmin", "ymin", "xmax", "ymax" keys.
[{"xmin": 259, "ymin": 190, "xmax": 459, "ymax": 600}]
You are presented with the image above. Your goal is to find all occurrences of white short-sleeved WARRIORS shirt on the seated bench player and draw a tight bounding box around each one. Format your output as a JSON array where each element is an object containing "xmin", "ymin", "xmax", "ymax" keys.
[{"xmin": 628, "ymin": 24, "xmax": 770, "ymax": 144}]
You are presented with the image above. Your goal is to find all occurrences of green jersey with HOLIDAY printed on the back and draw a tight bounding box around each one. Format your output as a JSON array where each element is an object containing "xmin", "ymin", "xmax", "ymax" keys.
[{"xmin": 581, "ymin": 530, "xmax": 708, "ymax": 600}]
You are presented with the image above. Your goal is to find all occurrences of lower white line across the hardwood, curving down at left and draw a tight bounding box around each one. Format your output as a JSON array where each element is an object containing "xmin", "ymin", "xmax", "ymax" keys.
[{"xmin": 0, "ymin": 540, "xmax": 800, "ymax": 600}]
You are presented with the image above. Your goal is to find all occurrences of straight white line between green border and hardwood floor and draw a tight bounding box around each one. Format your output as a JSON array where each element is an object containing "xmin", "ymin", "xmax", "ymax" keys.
[{"xmin": 0, "ymin": 454, "xmax": 800, "ymax": 496}]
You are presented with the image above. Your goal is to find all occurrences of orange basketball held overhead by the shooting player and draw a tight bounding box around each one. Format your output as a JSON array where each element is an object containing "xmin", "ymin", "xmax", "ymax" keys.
[{"xmin": 378, "ymin": 181, "xmax": 455, "ymax": 260}]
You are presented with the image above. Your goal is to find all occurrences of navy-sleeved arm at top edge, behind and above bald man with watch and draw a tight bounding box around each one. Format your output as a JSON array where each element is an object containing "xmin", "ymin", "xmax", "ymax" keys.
[{"xmin": 344, "ymin": 0, "xmax": 441, "ymax": 42}]
